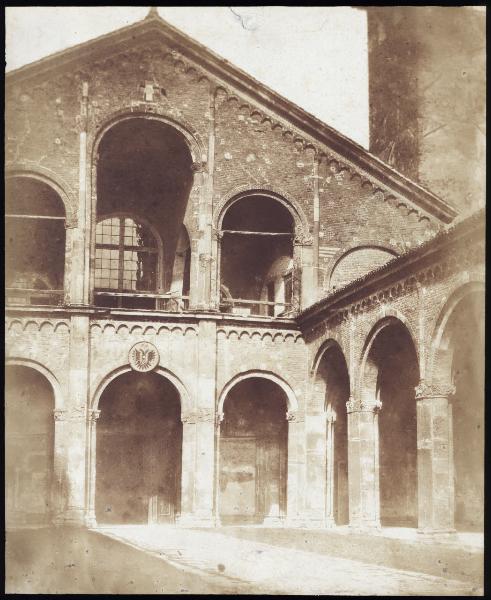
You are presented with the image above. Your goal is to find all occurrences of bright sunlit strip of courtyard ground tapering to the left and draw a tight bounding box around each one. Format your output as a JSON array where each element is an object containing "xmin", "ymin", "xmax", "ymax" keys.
[{"xmin": 98, "ymin": 526, "xmax": 482, "ymax": 596}]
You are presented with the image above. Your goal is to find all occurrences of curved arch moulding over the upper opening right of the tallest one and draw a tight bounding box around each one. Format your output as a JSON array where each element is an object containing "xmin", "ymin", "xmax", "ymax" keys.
[{"xmin": 213, "ymin": 184, "xmax": 309, "ymax": 237}]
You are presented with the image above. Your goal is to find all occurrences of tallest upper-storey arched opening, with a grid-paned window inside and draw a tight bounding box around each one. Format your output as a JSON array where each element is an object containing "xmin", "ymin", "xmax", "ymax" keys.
[{"xmin": 93, "ymin": 115, "xmax": 194, "ymax": 310}]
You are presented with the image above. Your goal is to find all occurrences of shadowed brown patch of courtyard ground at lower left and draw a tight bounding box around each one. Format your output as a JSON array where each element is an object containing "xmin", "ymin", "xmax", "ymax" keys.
[{"xmin": 5, "ymin": 529, "xmax": 252, "ymax": 594}]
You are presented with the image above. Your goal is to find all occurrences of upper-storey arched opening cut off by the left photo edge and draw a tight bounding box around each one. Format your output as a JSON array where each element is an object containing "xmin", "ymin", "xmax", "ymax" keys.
[{"xmin": 5, "ymin": 177, "xmax": 65, "ymax": 305}]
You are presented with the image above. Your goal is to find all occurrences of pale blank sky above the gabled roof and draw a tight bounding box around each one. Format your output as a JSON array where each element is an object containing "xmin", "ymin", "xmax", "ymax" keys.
[{"xmin": 5, "ymin": 6, "xmax": 368, "ymax": 147}]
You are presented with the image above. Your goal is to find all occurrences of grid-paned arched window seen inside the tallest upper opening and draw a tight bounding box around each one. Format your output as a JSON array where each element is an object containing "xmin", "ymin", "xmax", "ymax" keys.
[{"xmin": 95, "ymin": 215, "xmax": 162, "ymax": 308}]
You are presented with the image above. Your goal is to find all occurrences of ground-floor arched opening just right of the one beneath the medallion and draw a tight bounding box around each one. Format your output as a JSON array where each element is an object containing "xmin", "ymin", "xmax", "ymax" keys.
[{"xmin": 219, "ymin": 377, "xmax": 288, "ymax": 525}]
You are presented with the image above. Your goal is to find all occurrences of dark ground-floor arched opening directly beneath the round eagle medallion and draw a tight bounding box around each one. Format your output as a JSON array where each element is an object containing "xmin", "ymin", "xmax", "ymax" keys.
[{"xmin": 95, "ymin": 372, "xmax": 182, "ymax": 524}]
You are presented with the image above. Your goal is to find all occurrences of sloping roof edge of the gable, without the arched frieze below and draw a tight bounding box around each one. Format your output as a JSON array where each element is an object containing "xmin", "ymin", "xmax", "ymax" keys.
[{"xmin": 6, "ymin": 10, "xmax": 457, "ymax": 223}]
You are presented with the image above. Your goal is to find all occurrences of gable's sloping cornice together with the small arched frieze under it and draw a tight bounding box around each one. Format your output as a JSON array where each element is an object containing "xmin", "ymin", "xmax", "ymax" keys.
[{"xmin": 6, "ymin": 11, "xmax": 457, "ymax": 223}]
